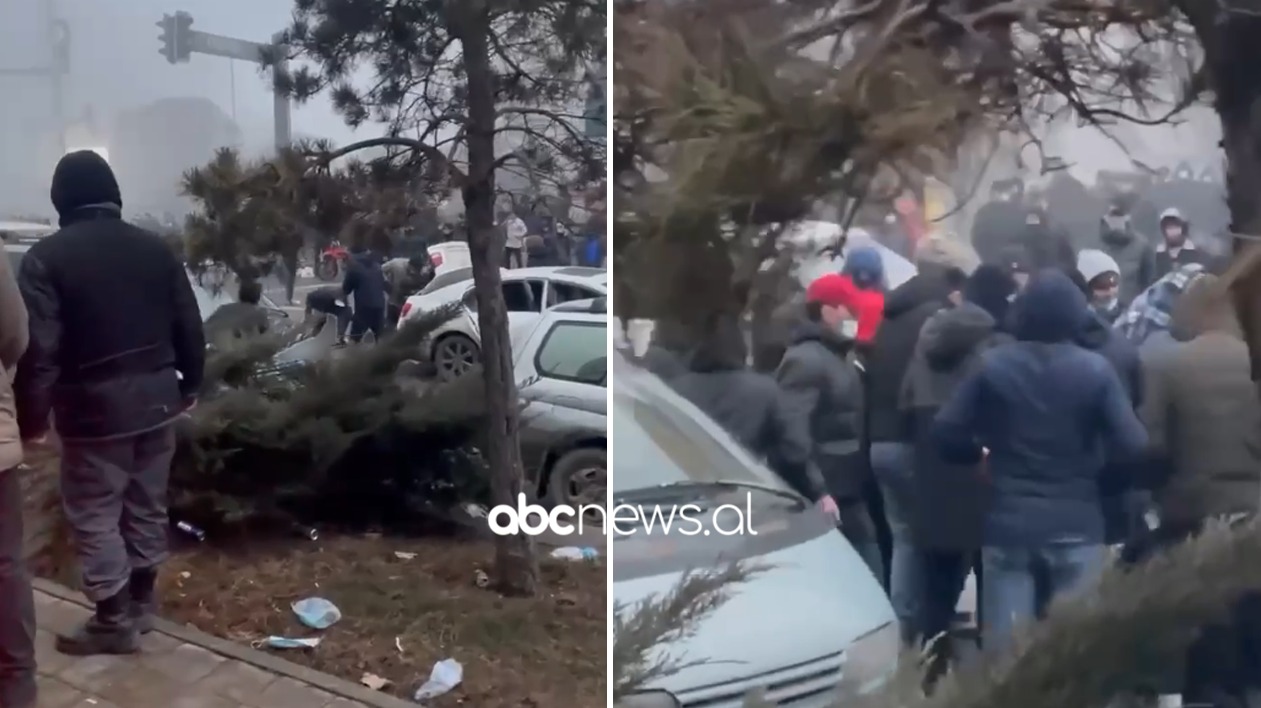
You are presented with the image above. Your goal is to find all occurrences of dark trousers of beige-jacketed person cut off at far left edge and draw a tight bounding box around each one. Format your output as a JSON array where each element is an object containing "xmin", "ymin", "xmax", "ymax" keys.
[{"xmin": 0, "ymin": 469, "xmax": 35, "ymax": 705}]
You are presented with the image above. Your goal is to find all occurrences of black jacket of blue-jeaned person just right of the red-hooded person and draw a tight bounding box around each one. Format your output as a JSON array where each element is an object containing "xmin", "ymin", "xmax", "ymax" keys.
[{"xmin": 864, "ymin": 274, "xmax": 948, "ymax": 443}]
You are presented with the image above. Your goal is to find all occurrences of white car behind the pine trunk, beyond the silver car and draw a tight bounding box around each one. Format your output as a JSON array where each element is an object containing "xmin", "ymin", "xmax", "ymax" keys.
[{"xmin": 398, "ymin": 265, "xmax": 609, "ymax": 379}]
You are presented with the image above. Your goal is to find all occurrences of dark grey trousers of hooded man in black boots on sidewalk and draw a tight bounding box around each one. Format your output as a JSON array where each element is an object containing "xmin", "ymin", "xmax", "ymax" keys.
[{"xmin": 62, "ymin": 425, "xmax": 175, "ymax": 602}]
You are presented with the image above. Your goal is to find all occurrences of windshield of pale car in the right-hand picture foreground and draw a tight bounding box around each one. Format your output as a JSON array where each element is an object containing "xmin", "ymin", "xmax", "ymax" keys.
[{"xmin": 612, "ymin": 371, "xmax": 787, "ymax": 495}]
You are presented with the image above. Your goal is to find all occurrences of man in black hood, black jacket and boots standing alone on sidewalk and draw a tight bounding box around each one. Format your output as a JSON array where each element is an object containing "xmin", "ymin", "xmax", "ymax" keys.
[{"xmin": 15, "ymin": 150, "xmax": 206, "ymax": 655}]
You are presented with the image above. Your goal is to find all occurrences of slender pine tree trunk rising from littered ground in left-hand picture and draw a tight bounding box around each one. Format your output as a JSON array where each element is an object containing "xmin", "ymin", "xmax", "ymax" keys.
[{"xmin": 449, "ymin": 9, "xmax": 538, "ymax": 596}]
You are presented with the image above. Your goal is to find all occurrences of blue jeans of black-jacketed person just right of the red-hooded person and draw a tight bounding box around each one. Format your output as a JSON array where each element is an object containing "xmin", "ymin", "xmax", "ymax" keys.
[{"xmin": 871, "ymin": 443, "xmax": 923, "ymax": 645}]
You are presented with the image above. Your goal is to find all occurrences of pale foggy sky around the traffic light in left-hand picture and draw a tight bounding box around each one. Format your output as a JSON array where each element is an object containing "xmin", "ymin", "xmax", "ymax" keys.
[{"xmin": 0, "ymin": 0, "xmax": 377, "ymax": 211}]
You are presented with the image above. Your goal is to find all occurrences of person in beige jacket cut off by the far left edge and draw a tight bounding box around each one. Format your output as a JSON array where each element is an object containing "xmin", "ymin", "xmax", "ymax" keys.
[{"xmin": 0, "ymin": 239, "xmax": 35, "ymax": 708}]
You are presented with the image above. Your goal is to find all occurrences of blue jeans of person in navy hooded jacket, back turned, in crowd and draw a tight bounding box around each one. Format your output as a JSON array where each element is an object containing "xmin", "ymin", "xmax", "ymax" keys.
[{"xmin": 981, "ymin": 541, "xmax": 1108, "ymax": 655}]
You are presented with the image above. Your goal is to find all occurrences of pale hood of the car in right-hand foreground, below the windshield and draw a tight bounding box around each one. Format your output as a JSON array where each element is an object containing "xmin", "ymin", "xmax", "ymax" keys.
[{"xmin": 614, "ymin": 517, "xmax": 894, "ymax": 697}]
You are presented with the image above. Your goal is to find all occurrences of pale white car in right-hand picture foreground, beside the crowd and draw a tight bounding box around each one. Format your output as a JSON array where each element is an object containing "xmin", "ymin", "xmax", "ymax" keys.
[{"xmin": 610, "ymin": 355, "xmax": 899, "ymax": 708}]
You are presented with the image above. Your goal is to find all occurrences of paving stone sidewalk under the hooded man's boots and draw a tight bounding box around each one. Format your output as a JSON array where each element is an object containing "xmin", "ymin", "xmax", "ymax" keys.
[{"xmin": 35, "ymin": 582, "xmax": 415, "ymax": 708}]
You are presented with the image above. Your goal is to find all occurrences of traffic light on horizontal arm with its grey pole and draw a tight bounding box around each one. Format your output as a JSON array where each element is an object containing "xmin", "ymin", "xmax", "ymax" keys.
[{"xmin": 158, "ymin": 11, "xmax": 293, "ymax": 150}]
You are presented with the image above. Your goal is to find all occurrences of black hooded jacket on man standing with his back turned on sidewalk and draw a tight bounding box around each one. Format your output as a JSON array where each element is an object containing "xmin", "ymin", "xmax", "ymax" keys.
[{"xmin": 14, "ymin": 151, "xmax": 206, "ymax": 440}]
